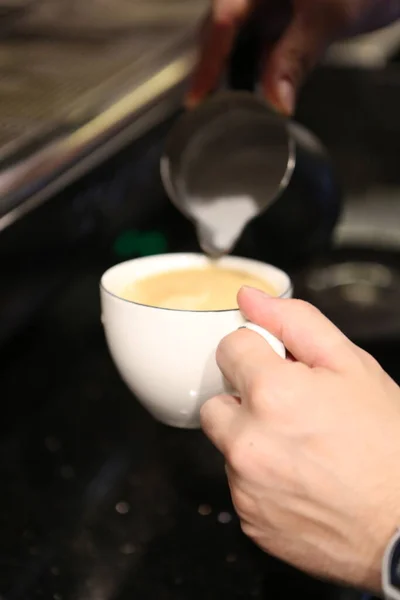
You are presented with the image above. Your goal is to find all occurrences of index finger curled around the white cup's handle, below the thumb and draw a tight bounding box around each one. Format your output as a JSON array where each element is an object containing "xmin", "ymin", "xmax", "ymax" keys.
[{"xmin": 217, "ymin": 329, "xmax": 286, "ymax": 401}]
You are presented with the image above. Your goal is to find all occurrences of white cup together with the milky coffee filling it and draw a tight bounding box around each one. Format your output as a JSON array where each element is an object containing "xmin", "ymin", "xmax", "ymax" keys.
[{"xmin": 100, "ymin": 254, "xmax": 292, "ymax": 429}]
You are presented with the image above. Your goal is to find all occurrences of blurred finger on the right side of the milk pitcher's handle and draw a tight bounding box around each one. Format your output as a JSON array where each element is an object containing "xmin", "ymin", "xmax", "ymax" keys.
[{"xmin": 262, "ymin": 8, "xmax": 336, "ymax": 116}]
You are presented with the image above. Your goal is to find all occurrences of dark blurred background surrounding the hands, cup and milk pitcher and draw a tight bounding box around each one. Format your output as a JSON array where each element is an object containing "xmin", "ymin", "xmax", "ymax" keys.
[{"xmin": 0, "ymin": 0, "xmax": 400, "ymax": 600}]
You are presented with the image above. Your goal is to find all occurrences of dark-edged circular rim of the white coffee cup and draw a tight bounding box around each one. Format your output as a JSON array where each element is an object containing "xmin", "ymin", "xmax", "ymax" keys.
[{"xmin": 100, "ymin": 252, "xmax": 293, "ymax": 315}]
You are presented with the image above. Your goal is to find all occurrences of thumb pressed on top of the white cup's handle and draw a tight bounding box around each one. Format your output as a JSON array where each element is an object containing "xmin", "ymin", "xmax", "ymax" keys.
[{"xmin": 238, "ymin": 287, "xmax": 354, "ymax": 370}]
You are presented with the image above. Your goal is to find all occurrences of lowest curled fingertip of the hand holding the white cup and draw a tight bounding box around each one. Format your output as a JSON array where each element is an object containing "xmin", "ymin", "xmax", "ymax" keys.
[{"xmin": 200, "ymin": 394, "xmax": 240, "ymax": 454}]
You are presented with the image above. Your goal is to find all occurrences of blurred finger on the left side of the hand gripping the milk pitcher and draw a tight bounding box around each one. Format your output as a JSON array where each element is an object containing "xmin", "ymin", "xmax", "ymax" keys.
[{"xmin": 185, "ymin": 0, "xmax": 252, "ymax": 108}]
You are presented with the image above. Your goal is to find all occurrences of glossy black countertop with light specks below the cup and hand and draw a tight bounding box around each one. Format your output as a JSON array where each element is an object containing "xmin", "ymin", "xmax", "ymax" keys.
[{"xmin": 0, "ymin": 265, "xmax": 362, "ymax": 600}]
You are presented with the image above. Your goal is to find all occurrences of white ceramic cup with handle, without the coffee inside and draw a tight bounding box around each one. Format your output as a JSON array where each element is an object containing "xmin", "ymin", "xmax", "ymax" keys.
[{"xmin": 100, "ymin": 254, "xmax": 292, "ymax": 429}]
